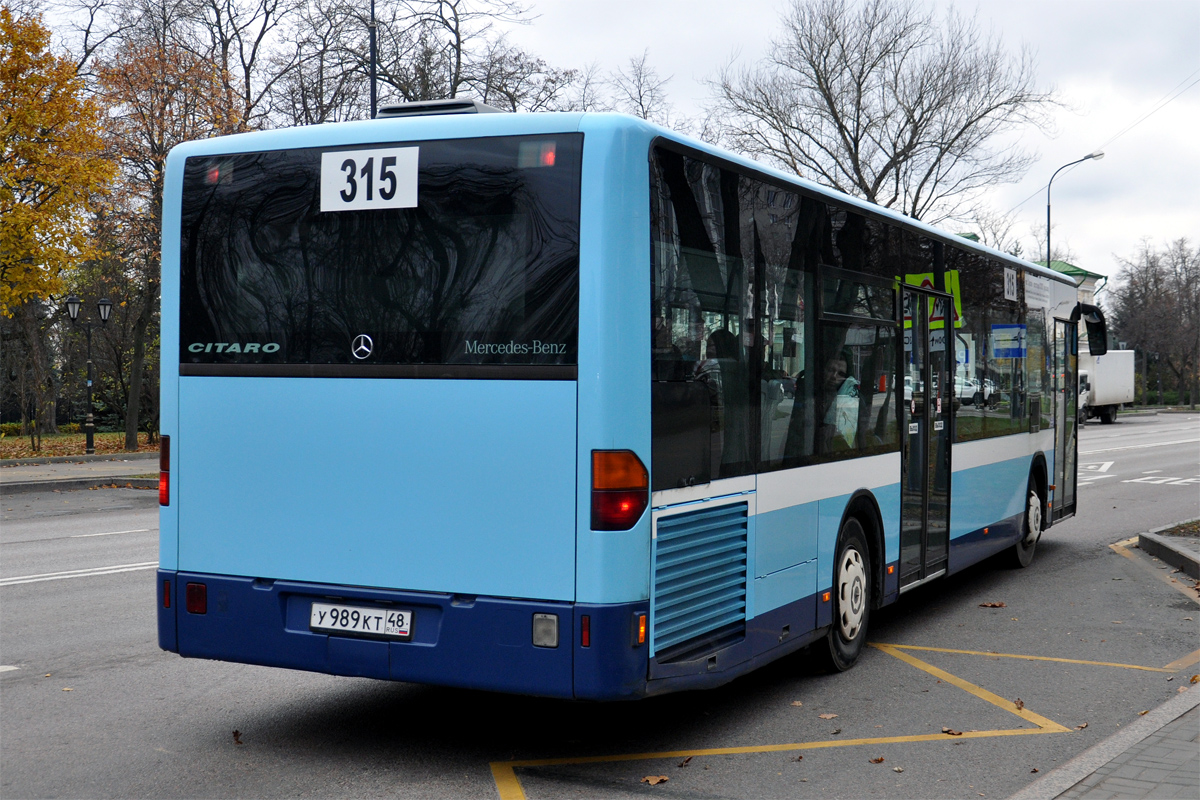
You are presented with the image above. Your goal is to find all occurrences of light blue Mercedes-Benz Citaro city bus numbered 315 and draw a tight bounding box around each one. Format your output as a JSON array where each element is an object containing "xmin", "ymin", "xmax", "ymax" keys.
[{"xmin": 157, "ymin": 102, "xmax": 1104, "ymax": 699}]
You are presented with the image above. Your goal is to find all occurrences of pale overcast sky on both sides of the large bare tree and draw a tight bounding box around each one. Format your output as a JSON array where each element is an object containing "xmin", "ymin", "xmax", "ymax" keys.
[{"xmin": 512, "ymin": 0, "xmax": 1200, "ymax": 286}]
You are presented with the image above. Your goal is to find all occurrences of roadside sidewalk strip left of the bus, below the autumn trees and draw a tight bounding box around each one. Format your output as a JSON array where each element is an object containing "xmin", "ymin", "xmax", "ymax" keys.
[{"xmin": 0, "ymin": 452, "xmax": 158, "ymax": 495}]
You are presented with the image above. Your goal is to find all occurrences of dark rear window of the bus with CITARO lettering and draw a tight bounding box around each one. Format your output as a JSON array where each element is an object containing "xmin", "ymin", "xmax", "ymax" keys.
[{"xmin": 180, "ymin": 134, "xmax": 583, "ymax": 378}]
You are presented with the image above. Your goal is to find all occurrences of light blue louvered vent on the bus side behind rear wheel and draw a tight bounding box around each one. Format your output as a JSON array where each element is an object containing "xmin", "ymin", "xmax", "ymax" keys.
[{"xmin": 652, "ymin": 503, "xmax": 746, "ymax": 658}]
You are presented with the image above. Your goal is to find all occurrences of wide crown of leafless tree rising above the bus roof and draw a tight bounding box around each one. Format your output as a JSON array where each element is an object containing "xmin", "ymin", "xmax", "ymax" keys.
[{"xmin": 710, "ymin": 0, "xmax": 1057, "ymax": 222}]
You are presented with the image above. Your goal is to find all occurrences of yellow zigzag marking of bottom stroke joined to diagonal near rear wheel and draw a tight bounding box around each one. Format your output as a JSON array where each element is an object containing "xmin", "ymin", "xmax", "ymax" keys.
[{"xmin": 488, "ymin": 643, "xmax": 1070, "ymax": 800}]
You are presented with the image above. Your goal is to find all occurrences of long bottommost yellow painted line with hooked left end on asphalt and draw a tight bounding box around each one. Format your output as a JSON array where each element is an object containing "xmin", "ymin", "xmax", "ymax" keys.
[{"xmin": 491, "ymin": 728, "xmax": 1051, "ymax": 800}]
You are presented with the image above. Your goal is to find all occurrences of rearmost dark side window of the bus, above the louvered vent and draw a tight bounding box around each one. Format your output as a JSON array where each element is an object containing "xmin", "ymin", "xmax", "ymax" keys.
[{"xmin": 650, "ymin": 150, "xmax": 754, "ymax": 491}]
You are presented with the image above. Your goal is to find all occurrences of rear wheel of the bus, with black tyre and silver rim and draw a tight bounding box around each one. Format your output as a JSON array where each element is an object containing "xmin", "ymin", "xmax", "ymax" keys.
[{"xmin": 817, "ymin": 517, "xmax": 871, "ymax": 672}]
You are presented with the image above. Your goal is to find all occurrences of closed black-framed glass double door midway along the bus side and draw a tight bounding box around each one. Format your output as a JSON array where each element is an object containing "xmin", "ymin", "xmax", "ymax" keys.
[{"xmin": 900, "ymin": 287, "xmax": 954, "ymax": 590}]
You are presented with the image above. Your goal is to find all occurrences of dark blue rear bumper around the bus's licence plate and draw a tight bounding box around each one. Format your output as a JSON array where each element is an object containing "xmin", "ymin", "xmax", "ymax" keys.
[{"xmin": 157, "ymin": 570, "xmax": 647, "ymax": 699}]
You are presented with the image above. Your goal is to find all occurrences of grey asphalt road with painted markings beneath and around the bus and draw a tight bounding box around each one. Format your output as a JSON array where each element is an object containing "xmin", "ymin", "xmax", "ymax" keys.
[{"xmin": 0, "ymin": 415, "xmax": 1200, "ymax": 798}]
